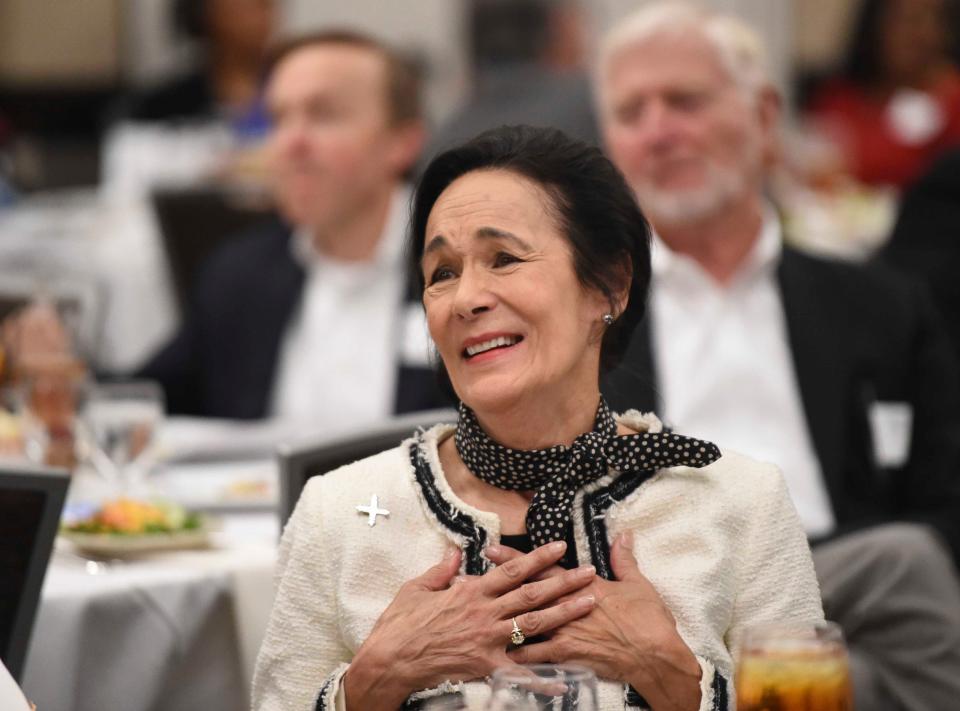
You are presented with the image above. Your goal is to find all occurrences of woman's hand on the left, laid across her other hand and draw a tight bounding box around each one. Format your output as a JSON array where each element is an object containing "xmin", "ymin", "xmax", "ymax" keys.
[{"xmin": 344, "ymin": 542, "xmax": 596, "ymax": 711}]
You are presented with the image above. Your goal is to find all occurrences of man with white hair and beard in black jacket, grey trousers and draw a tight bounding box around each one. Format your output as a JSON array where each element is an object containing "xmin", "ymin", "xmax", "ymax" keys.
[{"xmin": 597, "ymin": 2, "xmax": 960, "ymax": 711}]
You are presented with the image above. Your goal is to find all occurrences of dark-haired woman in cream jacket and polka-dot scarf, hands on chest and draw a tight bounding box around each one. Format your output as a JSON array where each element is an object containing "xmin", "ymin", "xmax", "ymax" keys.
[{"xmin": 254, "ymin": 127, "xmax": 822, "ymax": 711}]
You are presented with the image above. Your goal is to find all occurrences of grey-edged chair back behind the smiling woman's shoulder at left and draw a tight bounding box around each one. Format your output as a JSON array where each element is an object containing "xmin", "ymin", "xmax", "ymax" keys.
[{"xmin": 278, "ymin": 408, "xmax": 457, "ymax": 527}]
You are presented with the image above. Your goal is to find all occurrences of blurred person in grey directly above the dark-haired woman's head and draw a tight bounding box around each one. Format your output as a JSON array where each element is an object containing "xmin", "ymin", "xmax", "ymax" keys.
[{"xmin": 423, "ymin": 0, "xmax": 599, "ymax": 164}]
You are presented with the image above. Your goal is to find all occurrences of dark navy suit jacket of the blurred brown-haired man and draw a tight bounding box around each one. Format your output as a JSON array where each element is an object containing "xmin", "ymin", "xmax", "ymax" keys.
[{"xmin": 138, "ymin": 220, "xmax": 450, "ymax": 419}]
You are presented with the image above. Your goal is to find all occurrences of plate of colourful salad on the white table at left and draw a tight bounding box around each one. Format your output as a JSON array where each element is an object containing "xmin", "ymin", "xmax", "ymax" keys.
[{"xmin": 60, "ymin": 498, "xmax": 211, "ymax": 557}]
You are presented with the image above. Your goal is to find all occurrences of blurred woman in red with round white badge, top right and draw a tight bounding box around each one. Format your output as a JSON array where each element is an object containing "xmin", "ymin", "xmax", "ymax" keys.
[{"xmin": 809, "ymin": 0, "xmax": 960, "ymax": 188}]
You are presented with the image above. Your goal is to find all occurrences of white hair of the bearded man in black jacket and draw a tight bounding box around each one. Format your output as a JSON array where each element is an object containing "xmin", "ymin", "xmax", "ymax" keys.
[{"xmin": 597, "ymin": 0, "xmax": 772, "ymax": 97}]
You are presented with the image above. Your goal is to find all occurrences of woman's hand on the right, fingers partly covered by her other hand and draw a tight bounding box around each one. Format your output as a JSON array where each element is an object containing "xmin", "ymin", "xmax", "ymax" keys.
[{"xmin": 491, "ymin": 533, "xmax": 701, "ymax": 711}]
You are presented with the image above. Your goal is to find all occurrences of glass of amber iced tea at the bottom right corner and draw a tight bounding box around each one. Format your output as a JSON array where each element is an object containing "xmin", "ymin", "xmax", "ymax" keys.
[{"xmin": 736, "ymin": 622, "xmax": 853, "ymax": 711}]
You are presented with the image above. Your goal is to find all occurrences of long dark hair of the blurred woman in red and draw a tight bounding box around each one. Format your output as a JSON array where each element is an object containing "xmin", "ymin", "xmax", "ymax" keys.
[{"xmin": 843, "ymin": 0, "xmax": 960, "ymax": 86}]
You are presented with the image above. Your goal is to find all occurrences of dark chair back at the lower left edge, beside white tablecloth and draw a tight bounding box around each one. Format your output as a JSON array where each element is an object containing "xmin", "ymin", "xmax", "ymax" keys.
[{"xmin": 0, "ymin": 465, "xmax": 70, "ymax": 680}]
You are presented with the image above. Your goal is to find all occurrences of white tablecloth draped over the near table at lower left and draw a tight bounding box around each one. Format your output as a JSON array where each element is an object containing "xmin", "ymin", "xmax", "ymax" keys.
[{"xmin": 23, "ymin": 513, "xmax": 278, "ymax": 711}]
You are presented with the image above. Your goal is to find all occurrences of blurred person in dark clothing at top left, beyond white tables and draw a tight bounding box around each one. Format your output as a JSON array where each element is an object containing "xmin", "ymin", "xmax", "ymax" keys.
[{"xmin": 120, "ymin": 0, "xmax": 278, "ymax": 137}]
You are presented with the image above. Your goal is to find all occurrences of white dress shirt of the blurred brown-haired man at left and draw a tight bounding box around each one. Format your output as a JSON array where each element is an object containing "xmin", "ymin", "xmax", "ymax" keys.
[{"xmin": 271, "ymin": 189, "xmax": 410, "ymax": 429}]
